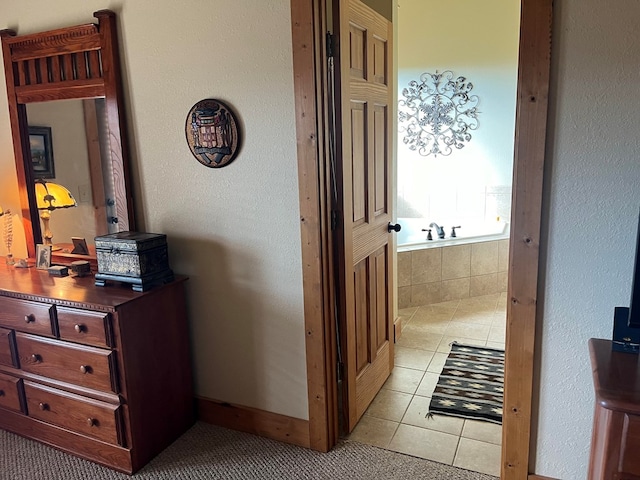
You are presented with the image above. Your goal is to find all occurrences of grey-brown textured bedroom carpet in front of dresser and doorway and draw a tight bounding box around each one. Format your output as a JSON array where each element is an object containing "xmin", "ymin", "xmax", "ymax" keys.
[{"xmin": 0, "ymin": 422, "xmax": 495, "ymax": 480}]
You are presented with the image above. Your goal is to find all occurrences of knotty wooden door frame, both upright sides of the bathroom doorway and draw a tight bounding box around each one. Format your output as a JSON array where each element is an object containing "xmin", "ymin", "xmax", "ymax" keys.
[{"xmin": 291, "ymin": 0, "xmax": 553, "ymax": 480}]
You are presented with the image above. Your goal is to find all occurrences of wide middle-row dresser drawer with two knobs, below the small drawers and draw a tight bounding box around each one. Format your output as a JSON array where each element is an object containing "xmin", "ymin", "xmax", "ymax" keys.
[{"xmin": 16, "ymin": 333, "xmax": 118, "ymax": 393}]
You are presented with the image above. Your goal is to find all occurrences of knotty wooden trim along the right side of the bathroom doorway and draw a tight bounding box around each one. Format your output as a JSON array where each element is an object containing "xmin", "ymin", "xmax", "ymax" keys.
[{"xmin": 500, "ymin": 0, "xmax": 553, "ymax": 480}]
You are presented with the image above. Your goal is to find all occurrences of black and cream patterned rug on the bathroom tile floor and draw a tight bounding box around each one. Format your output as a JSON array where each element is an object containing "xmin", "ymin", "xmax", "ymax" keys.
[{"xmin": 429, "ymin": 342, "xmax": 504, "ymax": 424}]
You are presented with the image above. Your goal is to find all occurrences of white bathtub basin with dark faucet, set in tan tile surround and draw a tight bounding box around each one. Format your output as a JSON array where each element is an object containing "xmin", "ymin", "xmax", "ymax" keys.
[{"xmin": 397, "ymin": 218, "xmax": 509, "ymax": 252}]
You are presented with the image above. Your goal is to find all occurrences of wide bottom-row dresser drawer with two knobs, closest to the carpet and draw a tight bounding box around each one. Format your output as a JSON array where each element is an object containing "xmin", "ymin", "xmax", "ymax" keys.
[{"xmin": 24, "ymin": 381, "xmax": 124, "ymax": 445}]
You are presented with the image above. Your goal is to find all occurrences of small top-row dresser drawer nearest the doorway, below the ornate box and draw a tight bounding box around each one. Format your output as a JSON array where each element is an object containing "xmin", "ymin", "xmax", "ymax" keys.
[{"xmin": 56, "ymin": 307, "xmax": 112, "ymax": 347}]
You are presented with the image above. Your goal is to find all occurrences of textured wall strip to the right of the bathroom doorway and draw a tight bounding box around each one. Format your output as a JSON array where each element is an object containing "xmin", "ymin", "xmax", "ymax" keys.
[{"xmin": 535, "ymin": 0, "xmax": 640, "ymax": 480}]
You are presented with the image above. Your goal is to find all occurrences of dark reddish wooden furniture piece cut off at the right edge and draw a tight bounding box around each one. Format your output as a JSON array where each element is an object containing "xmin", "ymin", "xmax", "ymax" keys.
[{"xmin": 588, "ymin": 338, "xmax": 640, "ymax": 480}]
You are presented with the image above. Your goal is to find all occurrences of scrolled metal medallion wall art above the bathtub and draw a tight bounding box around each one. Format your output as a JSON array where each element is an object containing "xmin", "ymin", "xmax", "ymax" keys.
[{"xmin": 398, "ymin": 70, "xmax": 480, "ymax": 157}]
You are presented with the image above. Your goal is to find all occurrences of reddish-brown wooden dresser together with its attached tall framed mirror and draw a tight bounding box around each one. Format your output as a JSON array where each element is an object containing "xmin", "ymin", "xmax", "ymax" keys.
[{"xmin": 0, "ymin": 10, "xmax": 195, "ymax": 473}]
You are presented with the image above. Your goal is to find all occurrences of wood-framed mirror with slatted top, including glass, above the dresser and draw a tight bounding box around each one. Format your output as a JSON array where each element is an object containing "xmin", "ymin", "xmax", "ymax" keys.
[{"xmin": 0, "ymin": 10, "xmax": 134, "ymax": 269}]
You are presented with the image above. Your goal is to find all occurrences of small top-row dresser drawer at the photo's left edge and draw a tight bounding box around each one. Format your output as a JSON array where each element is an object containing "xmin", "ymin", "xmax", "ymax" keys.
[{"xmin": 0, "ymin": 297, "xmax": 54, "ymax": 336}]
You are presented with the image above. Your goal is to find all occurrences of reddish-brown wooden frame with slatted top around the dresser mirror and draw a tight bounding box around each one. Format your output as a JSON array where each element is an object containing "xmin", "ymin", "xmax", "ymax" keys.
[{"xmin": 0, "ymin": 10, "xmax": 134, "ymax": 268}]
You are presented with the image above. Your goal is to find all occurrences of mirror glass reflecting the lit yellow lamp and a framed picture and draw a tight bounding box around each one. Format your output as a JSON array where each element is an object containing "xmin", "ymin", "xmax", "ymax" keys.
[{"xmin": 26, "ymin": 98, "xmax": 117, "ymax": 253}]
